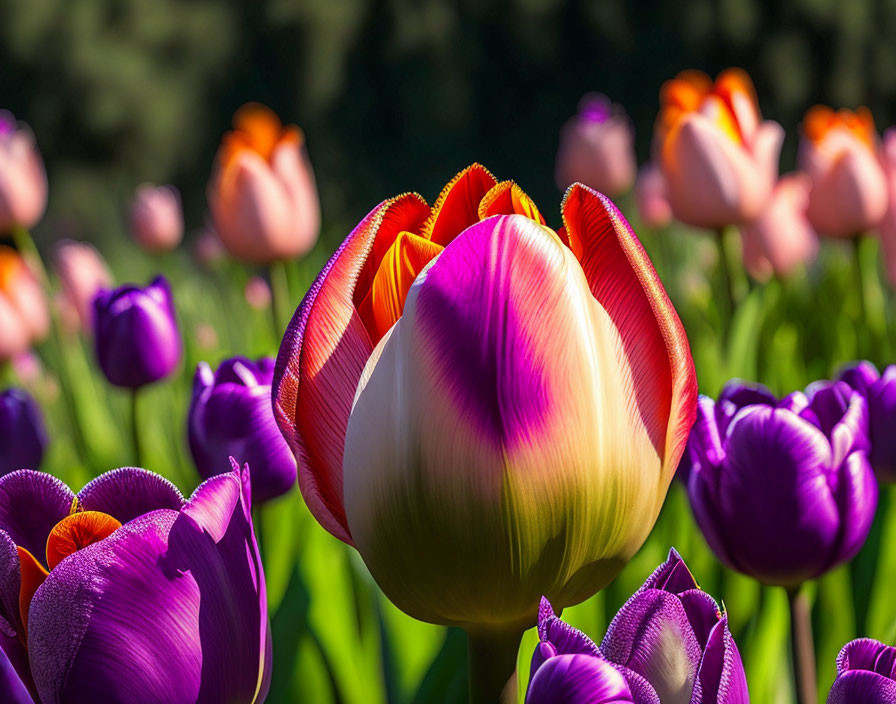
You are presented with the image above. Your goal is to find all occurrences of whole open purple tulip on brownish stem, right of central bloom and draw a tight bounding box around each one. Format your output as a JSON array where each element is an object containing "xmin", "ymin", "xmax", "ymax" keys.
[{"xmin": 688, "ymin": 382, "xmax": 877, "ymax": 586}]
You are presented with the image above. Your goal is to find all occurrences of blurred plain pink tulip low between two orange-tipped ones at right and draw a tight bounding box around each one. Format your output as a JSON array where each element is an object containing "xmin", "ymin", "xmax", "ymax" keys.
[{"xmin": 741, "ymin": 173, "xmax": 818, "ymax": 280}]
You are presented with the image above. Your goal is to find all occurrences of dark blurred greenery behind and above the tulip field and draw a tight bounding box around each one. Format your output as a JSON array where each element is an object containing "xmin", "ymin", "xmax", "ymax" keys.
[{"xmin": 0, "ymin": 0, "xmax": 896, "ymax": 248}]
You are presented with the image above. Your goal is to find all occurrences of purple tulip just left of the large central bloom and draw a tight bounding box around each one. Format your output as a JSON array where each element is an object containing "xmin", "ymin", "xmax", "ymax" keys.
[{"xmin": 187, "ymin": 357, "xmax": 296, "ymax": 504}]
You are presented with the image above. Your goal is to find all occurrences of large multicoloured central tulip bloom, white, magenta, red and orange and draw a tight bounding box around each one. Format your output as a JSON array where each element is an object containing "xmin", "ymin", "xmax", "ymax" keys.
[{"xmin": 274, "ymin": 165, "xmax": 696, "ymax": 628}]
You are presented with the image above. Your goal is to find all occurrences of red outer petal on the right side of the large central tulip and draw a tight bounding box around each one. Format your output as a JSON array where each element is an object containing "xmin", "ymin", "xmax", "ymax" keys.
[{"xmin": 562, "ymin": 184, "xmax": 697, "ymax": 481}]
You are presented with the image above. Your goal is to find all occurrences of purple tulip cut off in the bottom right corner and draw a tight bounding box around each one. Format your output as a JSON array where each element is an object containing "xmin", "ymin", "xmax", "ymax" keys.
[{"xmin": 828, "ymin": 638, "xmax": 896, "ymax": 704}]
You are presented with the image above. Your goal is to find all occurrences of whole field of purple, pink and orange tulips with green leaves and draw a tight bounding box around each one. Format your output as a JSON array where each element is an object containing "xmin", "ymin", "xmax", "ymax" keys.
[{"xmin": 0, "ymin": 33, "xmax": 896, "ymax": 704}]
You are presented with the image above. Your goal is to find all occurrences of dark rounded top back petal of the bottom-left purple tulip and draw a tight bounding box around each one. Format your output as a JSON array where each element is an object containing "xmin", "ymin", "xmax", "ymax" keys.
[{"xmin": 78, "ymin": 467, "xmax": 184, "ymax": 523}]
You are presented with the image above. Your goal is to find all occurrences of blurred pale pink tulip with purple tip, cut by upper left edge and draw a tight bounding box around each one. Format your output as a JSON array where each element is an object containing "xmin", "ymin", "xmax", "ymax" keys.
[{"xmin": 0, "ymin": 110, "xmax": 47, "ymax": 233}]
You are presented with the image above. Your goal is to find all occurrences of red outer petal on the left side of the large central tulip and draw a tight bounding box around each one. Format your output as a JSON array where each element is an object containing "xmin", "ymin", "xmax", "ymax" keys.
[{"xmin": 272, "ymin": 194, "xmax": 429, "ymax": 544}]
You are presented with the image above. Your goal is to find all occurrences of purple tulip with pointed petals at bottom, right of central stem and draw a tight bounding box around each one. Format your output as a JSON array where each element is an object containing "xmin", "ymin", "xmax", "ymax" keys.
[{"xmin": 526, "ymin": 550, "xmax": 750, "ymax": 704}]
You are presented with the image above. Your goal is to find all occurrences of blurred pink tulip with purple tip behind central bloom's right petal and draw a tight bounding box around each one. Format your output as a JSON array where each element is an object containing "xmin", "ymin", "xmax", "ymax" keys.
[{"xmin": 556, "ymin": 93, "xmax": 636, "ymax": 196}]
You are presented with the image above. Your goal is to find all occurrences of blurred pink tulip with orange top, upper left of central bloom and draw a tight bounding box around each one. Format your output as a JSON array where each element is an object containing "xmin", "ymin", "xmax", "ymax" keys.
[{"xmin": 208, "ymin": 103, "xmax": 320, "ymax": 264}]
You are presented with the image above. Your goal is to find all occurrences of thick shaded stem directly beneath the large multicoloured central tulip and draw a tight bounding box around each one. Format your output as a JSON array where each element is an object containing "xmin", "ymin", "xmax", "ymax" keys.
[{"xmin": 467, "ymin": 630, "xmax": 523, "ymax": 704}]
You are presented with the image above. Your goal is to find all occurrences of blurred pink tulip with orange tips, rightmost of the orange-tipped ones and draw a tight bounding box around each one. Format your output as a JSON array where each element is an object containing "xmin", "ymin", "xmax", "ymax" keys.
[{"xmin": 799, "ymin": 105, "xmax": 887, "ymax": 237}]
